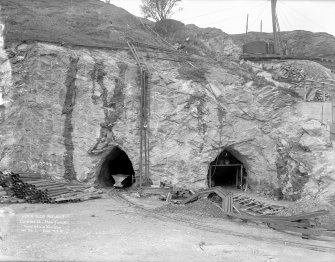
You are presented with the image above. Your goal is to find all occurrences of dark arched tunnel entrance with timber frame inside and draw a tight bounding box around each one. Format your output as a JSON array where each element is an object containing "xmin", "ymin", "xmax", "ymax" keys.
[{"xmin": 207, "ymin": 150, "xmax": 247, "ymax": 189}]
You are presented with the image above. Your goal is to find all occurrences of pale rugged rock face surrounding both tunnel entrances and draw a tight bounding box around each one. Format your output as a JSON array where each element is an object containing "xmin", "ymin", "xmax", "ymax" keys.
[{"xmin": 0, "ymin": 38, "xmax": 335, "ymax": 203}]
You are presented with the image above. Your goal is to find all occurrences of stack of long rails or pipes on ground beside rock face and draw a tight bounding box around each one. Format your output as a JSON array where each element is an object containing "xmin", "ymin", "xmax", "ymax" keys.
[{"xmin": 11, "ymin": 173, "xmax": 97, "ymax": 203}]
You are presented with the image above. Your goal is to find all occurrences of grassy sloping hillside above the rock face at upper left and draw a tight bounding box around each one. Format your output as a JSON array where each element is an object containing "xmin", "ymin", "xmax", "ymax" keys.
[{"xmin": 0, "ymin": 0, "xmax": 158, "ymax": 48}]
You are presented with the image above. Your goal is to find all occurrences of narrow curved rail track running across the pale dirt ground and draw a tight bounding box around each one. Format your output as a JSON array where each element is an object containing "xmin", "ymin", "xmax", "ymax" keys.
[{"xmin": 111, "ymin": 192, "xmax": 335, "ymax": 253}]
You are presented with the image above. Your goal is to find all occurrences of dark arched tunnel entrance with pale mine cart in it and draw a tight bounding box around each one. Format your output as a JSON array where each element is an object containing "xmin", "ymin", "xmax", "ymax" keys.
[{"xmin": 97, "ymin": 147, "xmax": 135, "ymax": 187}]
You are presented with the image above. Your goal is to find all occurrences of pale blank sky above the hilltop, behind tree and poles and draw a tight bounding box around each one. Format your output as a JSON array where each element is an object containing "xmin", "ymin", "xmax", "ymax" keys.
[{"xmin": 107, "ymin": 0, "xmax": 335, "ymax": 35}]
